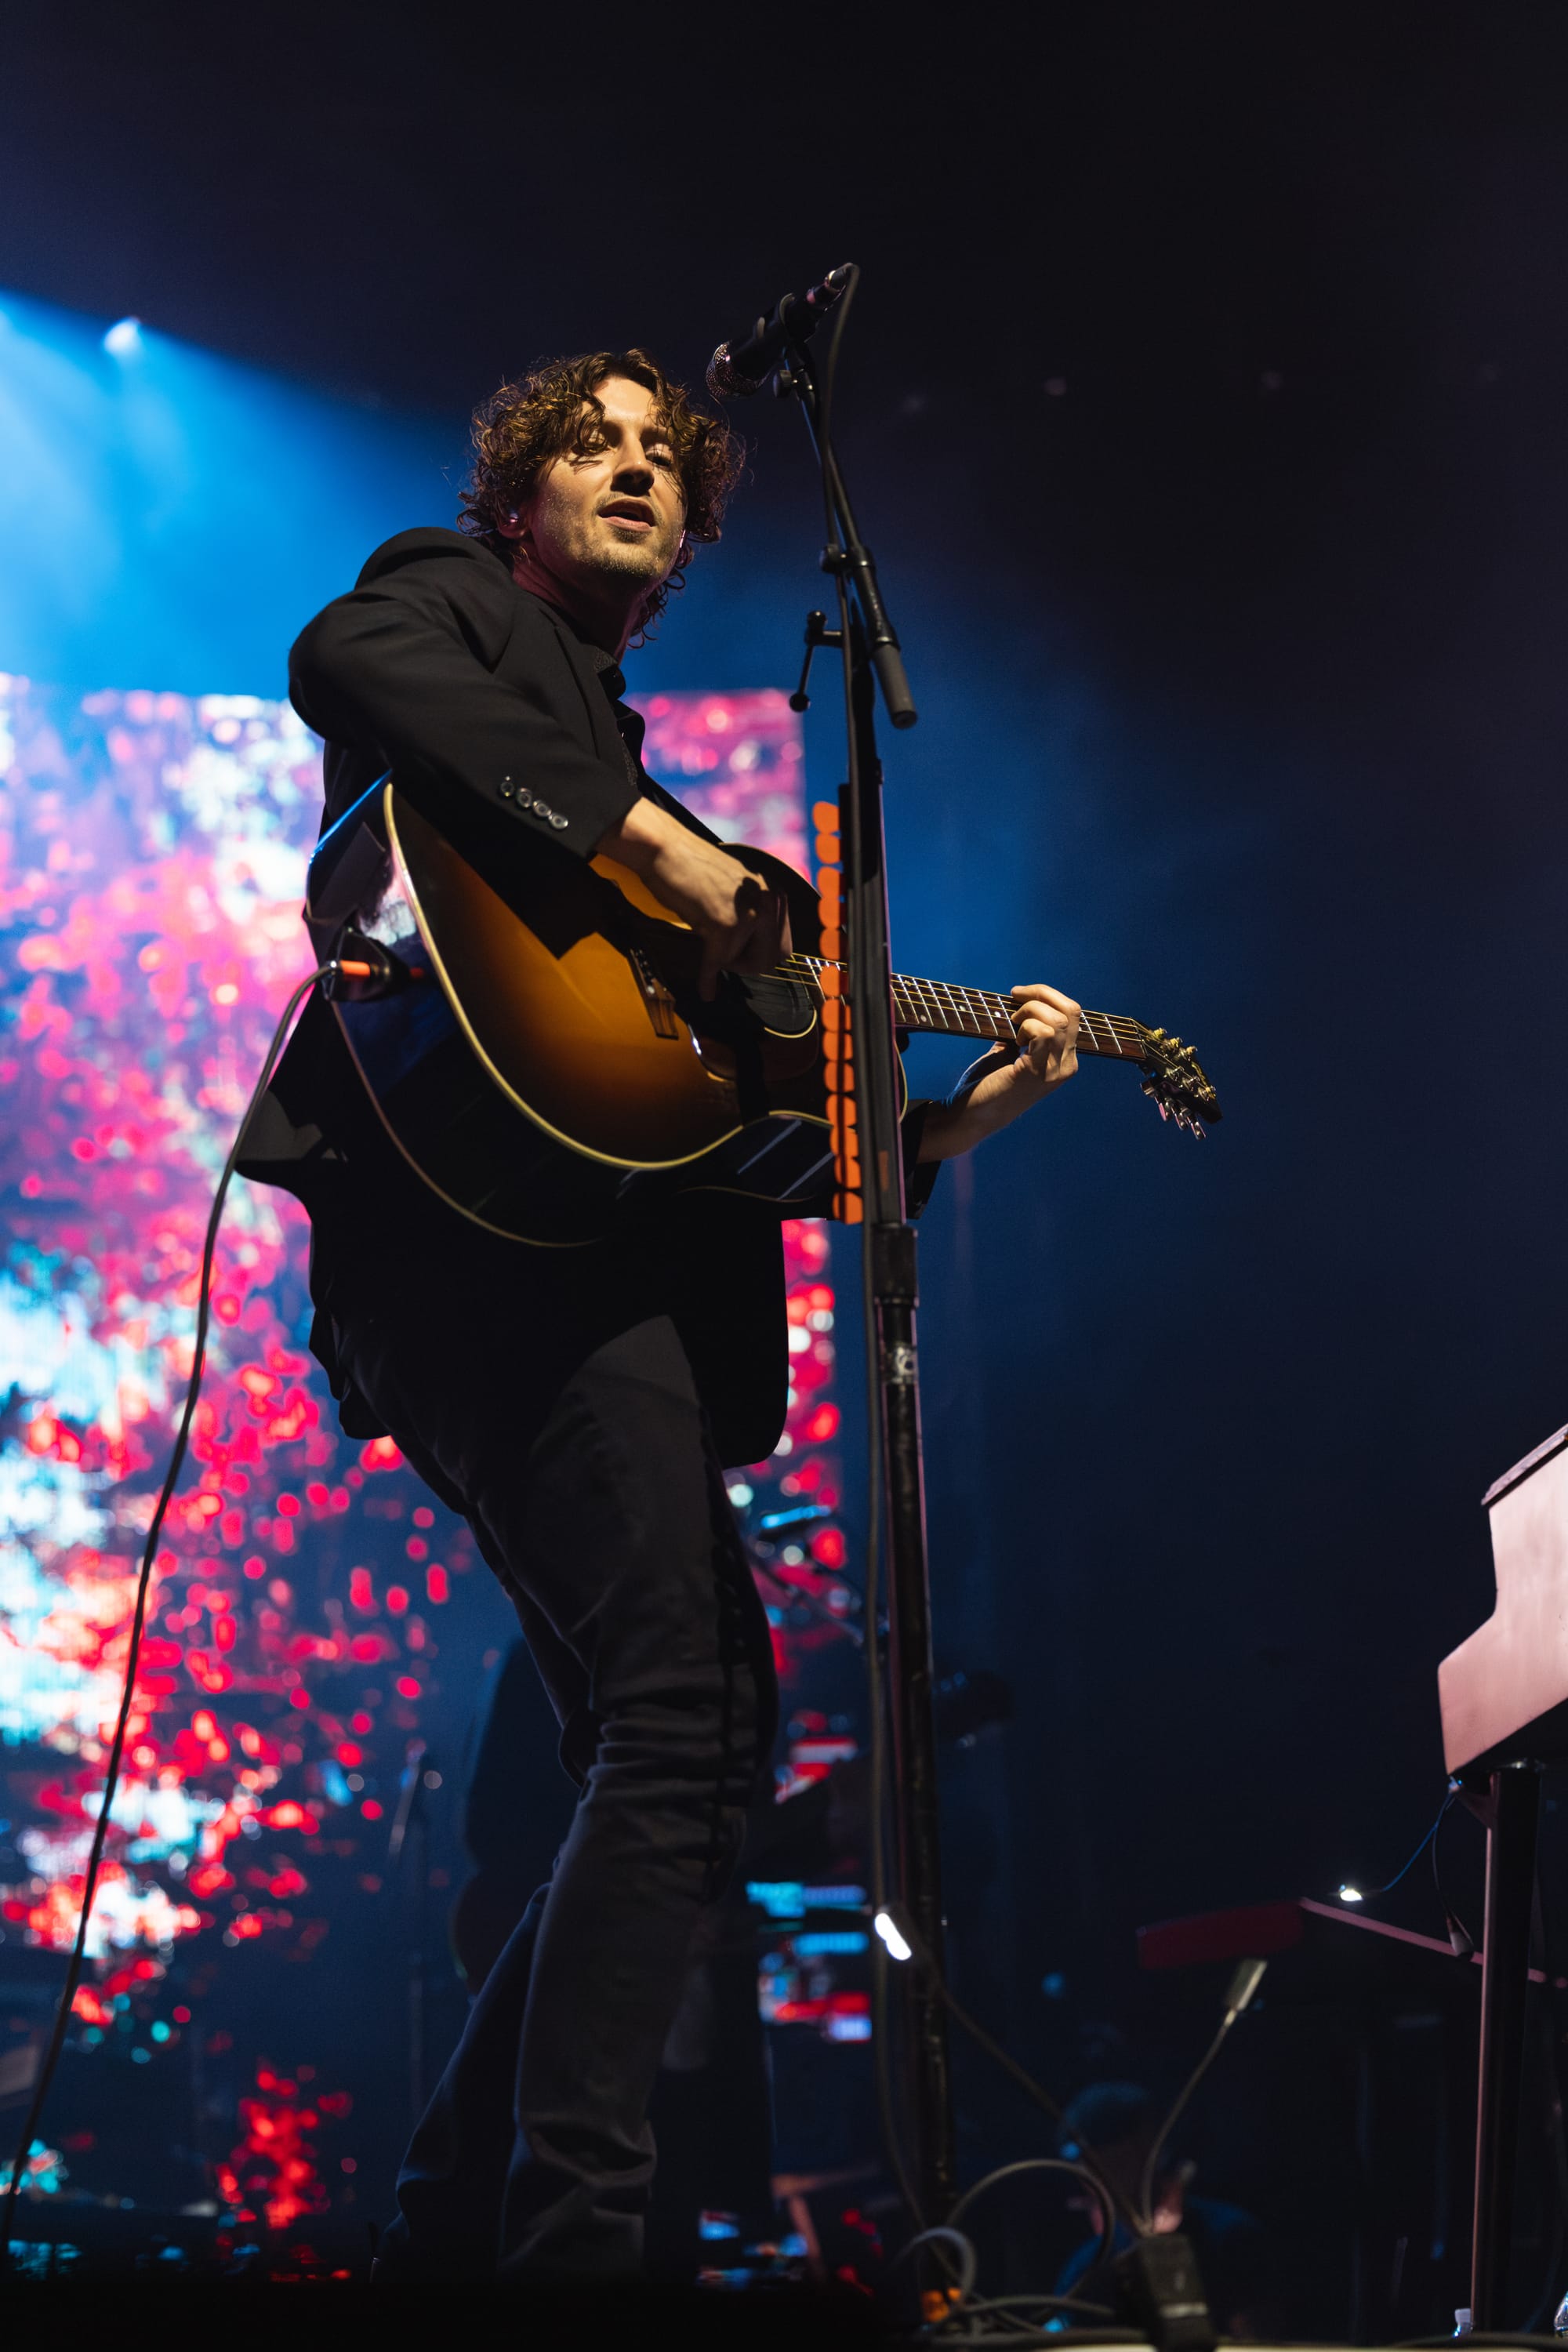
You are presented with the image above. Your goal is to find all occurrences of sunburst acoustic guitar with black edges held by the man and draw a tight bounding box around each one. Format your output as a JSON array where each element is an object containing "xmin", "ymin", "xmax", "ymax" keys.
[{"xmin": 306, "ymin": 776, "xmax": 1220, "ymax": 1247}]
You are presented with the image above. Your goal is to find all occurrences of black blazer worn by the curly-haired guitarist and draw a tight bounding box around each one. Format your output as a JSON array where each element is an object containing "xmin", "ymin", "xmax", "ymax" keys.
[{"xmin": 240, "ymin": 529, "xmax": 808, "ymax": 1463}]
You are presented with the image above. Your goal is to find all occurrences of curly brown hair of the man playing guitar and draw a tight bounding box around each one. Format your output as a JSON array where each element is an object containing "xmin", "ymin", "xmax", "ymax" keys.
[{"xmin": 459, "ymin": 350, "xmax": 746, "ymax": 630}]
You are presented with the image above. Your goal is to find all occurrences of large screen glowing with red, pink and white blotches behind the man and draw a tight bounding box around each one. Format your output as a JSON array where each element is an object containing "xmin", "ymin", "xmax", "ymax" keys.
[{"xmin": 0, "ymin": 680, "xmax": 846, "ymax": 2230}]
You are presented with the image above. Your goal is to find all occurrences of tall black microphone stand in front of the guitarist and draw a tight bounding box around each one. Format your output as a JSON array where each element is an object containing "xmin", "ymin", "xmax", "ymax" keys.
[{"xmin": 776, "ymin": 270, "xmax": 956, "ymax": 2225}]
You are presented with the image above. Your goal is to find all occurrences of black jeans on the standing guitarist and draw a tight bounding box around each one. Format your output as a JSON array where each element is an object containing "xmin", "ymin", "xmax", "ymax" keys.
[{"xmin": 318, "ymin": 1225, "xmax": 776, "ymax": 2277}]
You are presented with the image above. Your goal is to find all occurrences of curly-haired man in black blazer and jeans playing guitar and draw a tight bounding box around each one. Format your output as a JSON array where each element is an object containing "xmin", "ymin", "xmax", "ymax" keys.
[{"xmin": 245, "ymin": 350, "xmax": 1079, "ymax": 2279}]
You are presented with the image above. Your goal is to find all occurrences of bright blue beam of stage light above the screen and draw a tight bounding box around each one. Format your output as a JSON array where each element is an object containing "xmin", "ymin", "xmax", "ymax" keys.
[{"xmin": 0, "ymin": 287, "xmax": 463, "ymax": 696}]
